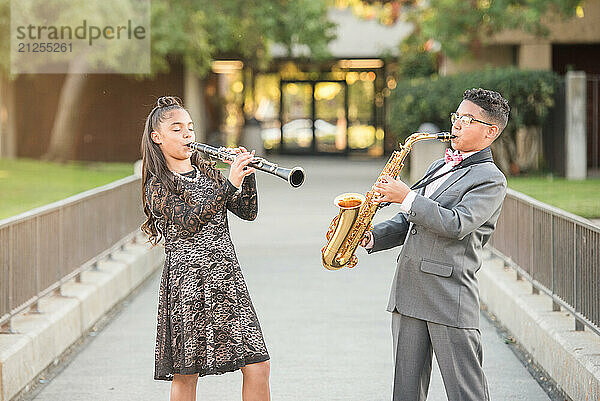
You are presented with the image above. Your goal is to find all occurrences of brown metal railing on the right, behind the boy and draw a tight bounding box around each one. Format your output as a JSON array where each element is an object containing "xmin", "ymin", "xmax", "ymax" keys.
[{"xmin": 489, "ymin": 189, "xmax": 600, "ymax": 335}]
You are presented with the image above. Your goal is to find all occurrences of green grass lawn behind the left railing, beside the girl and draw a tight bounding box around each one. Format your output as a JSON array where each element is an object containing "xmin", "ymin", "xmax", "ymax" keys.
[{"xmin": 0, "ymin": 159, "xmax": 133, "ymax": 219}]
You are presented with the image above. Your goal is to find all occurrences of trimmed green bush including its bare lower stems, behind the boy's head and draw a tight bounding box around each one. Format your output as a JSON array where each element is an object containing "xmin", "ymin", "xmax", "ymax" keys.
[{"xmin": 387, "ymin": 67, "xmax": 561, "ymax": 174}]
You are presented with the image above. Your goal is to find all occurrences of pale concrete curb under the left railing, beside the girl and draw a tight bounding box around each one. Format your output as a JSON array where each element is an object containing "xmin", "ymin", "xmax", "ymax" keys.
[{"xmin": 0, "ymin": 236, "xmax": 164, "ymax": 401}]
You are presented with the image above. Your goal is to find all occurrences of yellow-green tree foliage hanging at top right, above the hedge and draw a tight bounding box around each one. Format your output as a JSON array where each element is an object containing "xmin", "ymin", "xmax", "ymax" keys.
[{"xmin": 336, "ymin": 0, "xmax": 584, "ymax": 78}]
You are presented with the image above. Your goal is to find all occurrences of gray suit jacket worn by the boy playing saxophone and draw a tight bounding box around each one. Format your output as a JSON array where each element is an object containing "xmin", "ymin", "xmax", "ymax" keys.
[{"xmin": 369, "ymin": 149, "xmax": 506, "ymax": 328}]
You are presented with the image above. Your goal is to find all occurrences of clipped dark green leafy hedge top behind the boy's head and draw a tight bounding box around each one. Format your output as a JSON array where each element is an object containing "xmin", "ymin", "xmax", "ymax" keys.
[{"xmin": 388, "ymin": 67, "xmax": 560, "ymax": 140}]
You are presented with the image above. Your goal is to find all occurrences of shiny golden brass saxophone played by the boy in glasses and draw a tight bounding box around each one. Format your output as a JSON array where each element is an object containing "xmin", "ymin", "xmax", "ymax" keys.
[{"xmin": 321, "ymin": 132, "xmax": 454, "ymax": 270}]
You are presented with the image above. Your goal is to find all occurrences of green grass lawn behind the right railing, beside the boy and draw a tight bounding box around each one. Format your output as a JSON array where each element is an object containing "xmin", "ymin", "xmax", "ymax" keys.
[{"xmin": 508, "ymin": 176, "xmax": 600, "ymax": 219}]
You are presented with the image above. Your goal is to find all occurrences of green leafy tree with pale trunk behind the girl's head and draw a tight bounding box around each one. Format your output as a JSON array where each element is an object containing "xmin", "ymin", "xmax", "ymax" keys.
[{"xmin": 152, "ymin": 0, "xmax": 334, "ymax": 147}]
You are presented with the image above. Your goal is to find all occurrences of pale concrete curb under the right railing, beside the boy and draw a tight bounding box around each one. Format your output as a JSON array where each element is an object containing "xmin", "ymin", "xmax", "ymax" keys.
[{"xmin": 478, "ymin": 252, "xmax": 600, "ymax": 401}]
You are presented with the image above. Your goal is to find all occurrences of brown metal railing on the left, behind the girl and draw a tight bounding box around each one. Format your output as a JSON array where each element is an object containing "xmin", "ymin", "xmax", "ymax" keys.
[{"xmin": 0, "ymin": 175, "xmax": 143, "ymax": 333}]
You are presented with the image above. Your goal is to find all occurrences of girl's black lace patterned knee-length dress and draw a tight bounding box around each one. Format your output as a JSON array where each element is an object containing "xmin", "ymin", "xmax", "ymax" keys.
[{"xmin": 145, "ymin": 162, "xmax": 269, "ymax": 380}]
